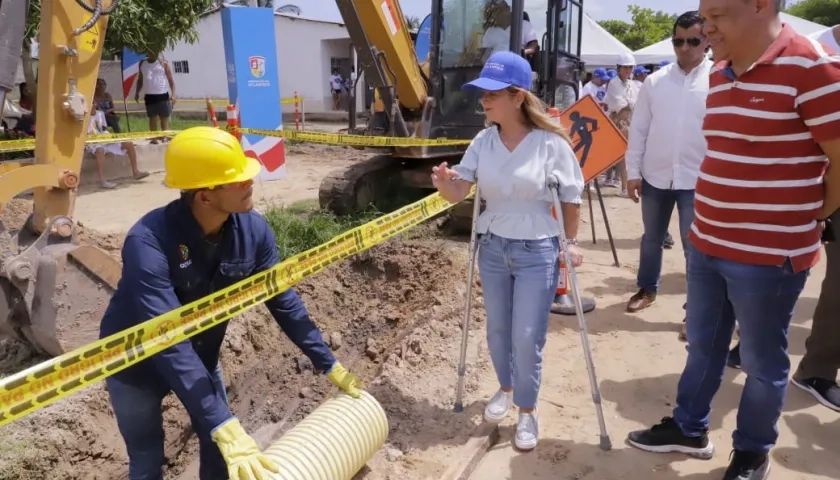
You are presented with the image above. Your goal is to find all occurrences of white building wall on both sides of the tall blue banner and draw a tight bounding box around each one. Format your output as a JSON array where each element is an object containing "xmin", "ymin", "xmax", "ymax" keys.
[{"xmin": 161, "ymin": 13, "xmax": 364, "ymax": 112}]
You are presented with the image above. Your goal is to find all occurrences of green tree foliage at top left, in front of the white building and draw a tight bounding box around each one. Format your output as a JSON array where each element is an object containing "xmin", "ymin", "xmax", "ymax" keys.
[{"xmin": 24, "ymin": 0, "xmax": 216, "ymax": 54}]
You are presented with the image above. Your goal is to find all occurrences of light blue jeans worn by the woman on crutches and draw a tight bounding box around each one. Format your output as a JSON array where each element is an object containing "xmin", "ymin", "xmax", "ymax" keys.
[{"xmin": 478, "ymin": 233, "xmax": 560, "ymax": 408}]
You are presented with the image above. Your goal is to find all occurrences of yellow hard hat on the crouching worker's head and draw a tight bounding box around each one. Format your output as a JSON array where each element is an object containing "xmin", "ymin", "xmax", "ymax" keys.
[{"xmin": 163, "ymin": 126, "xmax": 262, "ymax": 190}]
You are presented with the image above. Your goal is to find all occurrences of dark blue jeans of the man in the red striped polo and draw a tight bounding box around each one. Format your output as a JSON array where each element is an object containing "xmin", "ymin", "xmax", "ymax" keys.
[{"xmin": 674, "ymin": 249, "xmax": 808, "ymax": 452}]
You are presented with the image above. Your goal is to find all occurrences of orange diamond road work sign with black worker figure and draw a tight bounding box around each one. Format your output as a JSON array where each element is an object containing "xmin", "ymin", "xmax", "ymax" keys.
[{"xmin": 560, "ymin": 95, "xmax": 627, "ymax": 182}]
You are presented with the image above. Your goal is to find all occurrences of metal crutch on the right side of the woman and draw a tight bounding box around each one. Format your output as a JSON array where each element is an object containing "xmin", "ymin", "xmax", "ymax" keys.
[{"xmin": 548, "ymin": 175, "xmax": 612, "ymax": 450}]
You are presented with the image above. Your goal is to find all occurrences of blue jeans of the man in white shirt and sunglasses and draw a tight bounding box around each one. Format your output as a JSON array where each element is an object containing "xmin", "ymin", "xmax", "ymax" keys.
[{"xmin": 636, "ymin": 180, "xmax": 694, "ymax": 293}]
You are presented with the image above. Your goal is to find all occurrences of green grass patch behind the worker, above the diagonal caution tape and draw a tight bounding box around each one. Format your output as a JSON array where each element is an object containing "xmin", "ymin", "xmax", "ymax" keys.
[{"xmin": 265, "ymin": 200, "xmax": 383, "ymax": 259}]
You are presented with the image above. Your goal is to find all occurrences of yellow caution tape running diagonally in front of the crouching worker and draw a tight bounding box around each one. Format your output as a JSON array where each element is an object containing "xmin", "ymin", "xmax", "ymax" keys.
[{"xmin": 0, "ymin": 191, "xmax": 474, "ymax": 426}]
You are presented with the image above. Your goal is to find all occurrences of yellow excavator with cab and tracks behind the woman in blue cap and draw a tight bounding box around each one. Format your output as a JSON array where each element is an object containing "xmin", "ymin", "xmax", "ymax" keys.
[{"xmin": 319, "ymin": 0, "xmax": 583, "ymax": 219}]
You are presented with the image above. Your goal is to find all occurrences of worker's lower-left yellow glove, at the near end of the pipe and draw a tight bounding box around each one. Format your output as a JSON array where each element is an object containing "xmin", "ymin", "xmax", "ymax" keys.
[{"xmin": 210, "ymin": 418, "xmax": 280, "ymax": 480}]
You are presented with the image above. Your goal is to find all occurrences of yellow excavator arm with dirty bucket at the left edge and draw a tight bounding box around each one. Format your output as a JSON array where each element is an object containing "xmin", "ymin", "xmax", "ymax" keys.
[{"xmin": 0, "ymin": 0, "xmax": 121, "ymax": 355}]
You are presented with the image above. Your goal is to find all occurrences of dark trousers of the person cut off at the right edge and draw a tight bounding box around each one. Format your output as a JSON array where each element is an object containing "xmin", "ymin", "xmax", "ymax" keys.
[{"xmin": 796, "ymin": 227, "xmax": 840, "ymax": 380}]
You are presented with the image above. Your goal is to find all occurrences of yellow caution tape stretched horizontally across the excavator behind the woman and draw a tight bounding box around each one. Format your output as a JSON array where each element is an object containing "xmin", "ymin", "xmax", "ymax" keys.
[{"xmin": 236, "ymin": 128, "xmax": 472, "ymax": 147}]
